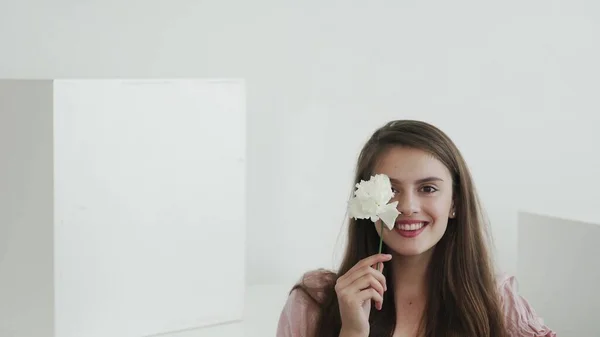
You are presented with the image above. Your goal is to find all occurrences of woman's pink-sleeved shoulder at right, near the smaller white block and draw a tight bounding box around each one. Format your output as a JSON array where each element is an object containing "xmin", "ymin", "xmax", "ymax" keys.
[{"xmin": 496, "ymin": 274, "xmax": 556, "ymax": 337}]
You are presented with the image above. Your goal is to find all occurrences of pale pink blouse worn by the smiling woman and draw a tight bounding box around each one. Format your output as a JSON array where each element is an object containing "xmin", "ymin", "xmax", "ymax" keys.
[{"xmin": 277, "ymin": 271, "xmax": 556, "ymax": 337}]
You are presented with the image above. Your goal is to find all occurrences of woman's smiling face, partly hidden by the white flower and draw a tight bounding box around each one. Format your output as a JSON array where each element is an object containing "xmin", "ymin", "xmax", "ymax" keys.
[{"xmin": 373, "ymin": 147, "xmax": 454, "ymax": 256}]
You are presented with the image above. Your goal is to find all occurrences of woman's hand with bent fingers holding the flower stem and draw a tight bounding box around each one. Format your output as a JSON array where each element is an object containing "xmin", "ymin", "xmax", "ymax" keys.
[{"xmin": 335, "ymin": 254, "xmax": 392, "ymax": 337}]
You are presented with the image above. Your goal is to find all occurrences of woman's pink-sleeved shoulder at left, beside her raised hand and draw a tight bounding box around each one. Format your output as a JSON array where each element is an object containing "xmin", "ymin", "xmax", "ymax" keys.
[{"xmin": 277, "ymin": 269, "xmax": 336, "ymax": 337}]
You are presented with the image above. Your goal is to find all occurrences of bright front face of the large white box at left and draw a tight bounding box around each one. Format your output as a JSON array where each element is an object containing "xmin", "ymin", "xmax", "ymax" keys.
[{"xmin": 54, "ymin": 80, "xmax": 246, "ymax": 337}]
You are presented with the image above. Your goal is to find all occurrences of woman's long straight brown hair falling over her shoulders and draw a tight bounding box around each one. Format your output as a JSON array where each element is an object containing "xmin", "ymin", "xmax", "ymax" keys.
[{"xmin": 292, "ymin": 120, "xmax": 507, "ymax": 337}]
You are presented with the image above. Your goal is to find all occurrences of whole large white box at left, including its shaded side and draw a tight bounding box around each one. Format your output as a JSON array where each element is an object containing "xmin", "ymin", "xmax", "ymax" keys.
[{"xmin": 0, "ymin": 79, "xmax": 246, "ymax": 337}]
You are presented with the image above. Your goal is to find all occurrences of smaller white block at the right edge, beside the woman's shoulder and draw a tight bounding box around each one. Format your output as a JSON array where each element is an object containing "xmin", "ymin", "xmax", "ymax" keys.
[{"xmin": 517, "ymin": 212, "xmax": 600, "ymax": 336}]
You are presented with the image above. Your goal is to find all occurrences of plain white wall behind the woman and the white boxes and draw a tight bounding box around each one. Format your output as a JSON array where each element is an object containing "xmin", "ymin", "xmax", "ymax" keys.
[{"xmin": 0, "ymin": 0, "xmax": 600, "ymax": 334}]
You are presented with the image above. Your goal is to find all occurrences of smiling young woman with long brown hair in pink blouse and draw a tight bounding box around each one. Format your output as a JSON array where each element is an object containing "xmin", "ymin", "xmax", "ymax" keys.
[{"xmin": 277, "ymin": 120, "xmax": 556, "ymax": 337}]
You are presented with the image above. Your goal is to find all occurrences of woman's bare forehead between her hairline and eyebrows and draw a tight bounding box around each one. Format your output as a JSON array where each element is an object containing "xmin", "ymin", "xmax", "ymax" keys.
[{"xmin": 374, "ymin": 147, "xmax": 451, "ymax": 181}]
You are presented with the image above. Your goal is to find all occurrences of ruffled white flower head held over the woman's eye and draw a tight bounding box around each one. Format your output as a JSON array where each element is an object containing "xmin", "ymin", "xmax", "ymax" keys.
[{"xmin": 348, "ymin": 174, "xmax": 400, "ymax": 230}]
